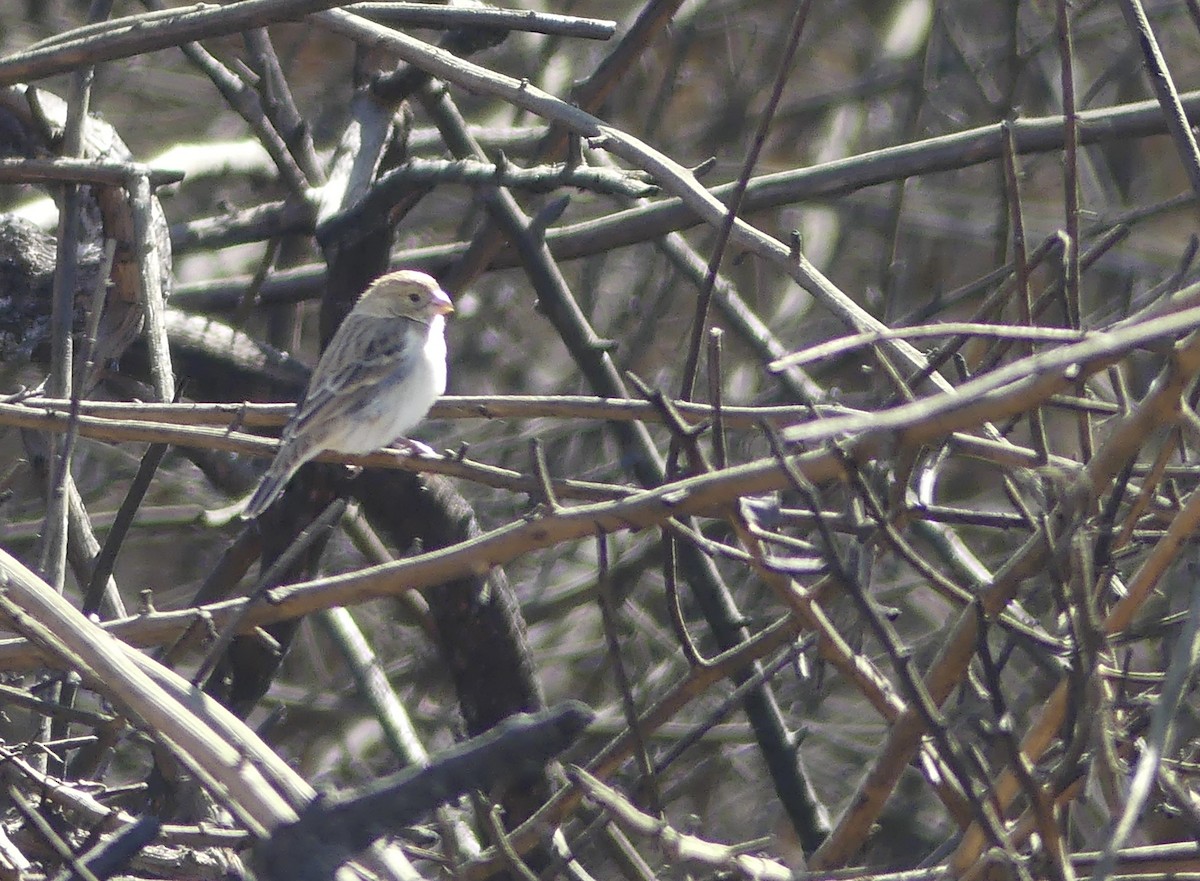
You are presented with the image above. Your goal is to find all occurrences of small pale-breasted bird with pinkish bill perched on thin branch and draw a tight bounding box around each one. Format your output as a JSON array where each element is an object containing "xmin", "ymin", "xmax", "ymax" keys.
[{"xmin": 241, "ymin": 269, "xmax": 454, "ymax": 519}]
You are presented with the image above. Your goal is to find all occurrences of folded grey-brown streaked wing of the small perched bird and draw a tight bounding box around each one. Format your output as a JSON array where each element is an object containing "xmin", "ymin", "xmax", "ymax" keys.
[{"xmin": 283, "ymin": 314, "xmax": 424, "ymax": 439}]
